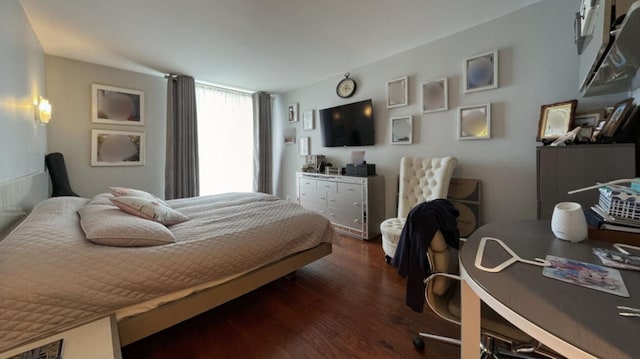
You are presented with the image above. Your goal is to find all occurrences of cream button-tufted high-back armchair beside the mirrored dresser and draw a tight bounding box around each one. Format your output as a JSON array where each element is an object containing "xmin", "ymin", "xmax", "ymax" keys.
[{"xmin": 380, "ymin": 157, "xmax": 458, "ymax": 262}]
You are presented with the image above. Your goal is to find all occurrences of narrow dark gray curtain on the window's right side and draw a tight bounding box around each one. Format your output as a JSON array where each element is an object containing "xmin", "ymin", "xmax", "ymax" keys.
[{"xmin": 253, "ymin": 92, "xmax": 273, "ymax": 194}]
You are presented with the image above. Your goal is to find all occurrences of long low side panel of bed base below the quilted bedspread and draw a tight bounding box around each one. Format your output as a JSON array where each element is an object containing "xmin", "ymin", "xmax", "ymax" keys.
[{"xmin": 118, "ymin": 243, "xmax": 331, "ymax": 346}]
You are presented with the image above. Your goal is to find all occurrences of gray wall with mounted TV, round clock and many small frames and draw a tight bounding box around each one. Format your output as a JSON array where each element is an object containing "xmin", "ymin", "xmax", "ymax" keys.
[{"xmin": 273, "ymin": 0, "xmax": 624, "ymax": 222}]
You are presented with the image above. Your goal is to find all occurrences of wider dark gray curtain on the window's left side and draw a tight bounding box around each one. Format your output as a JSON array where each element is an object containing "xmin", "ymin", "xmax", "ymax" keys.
[{"xmin": 164, "ymin": 76, "xmax": 200, "ymax": 199}]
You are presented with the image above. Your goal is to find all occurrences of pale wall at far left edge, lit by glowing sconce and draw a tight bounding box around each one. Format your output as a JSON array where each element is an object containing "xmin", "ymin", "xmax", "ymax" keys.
[{"xmin": 0, "ymin": 0, "xmax": 47, "ymax": 183}]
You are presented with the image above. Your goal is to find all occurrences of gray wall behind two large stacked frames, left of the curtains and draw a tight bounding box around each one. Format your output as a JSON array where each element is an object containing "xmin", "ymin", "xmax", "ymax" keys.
[{"xmin": 46, "ymin": 56, "xmax": 167, "ymax": 197}]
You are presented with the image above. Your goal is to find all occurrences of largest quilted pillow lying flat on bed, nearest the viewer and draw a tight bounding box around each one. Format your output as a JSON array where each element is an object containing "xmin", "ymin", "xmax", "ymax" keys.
[{"xmin": 78, "ymin": 205, "xmax": 176, "ymax": 247}]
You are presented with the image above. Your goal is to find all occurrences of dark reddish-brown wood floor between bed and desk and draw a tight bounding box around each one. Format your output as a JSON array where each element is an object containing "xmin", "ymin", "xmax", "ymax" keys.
[{"xmin": 123, "ymin": 237, "xmax": 460, "ymax": 359}]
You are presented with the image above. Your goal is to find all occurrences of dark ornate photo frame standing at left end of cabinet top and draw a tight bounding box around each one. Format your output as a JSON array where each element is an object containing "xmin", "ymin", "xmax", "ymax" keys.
[{"xmin": 536, "ymin": 100, "xmax": 578, "ymax": 142}]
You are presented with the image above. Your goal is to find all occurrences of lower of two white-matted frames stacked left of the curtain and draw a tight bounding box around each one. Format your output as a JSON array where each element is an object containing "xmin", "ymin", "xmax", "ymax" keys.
[{"xmin": 91, "ymin": 130, "xmax": 145, "ymax": 166}]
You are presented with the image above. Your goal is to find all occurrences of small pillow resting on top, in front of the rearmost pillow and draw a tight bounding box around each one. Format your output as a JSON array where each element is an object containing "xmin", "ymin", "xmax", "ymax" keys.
[{"xmin": 110, "ymin": 196, "xmax": 189, "ymax": 226}]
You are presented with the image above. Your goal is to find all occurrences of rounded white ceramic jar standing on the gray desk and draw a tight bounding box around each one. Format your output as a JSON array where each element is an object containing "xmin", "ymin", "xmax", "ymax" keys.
[{"xmin": 551, "ymin": 202, "xmax": 587, "ymax": 243}]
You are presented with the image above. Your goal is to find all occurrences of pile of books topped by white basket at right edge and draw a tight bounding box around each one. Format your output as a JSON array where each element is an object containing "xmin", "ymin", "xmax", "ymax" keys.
[{"xmin": 585, "ymin": 186, "xmax": 640, "ymax": 233}]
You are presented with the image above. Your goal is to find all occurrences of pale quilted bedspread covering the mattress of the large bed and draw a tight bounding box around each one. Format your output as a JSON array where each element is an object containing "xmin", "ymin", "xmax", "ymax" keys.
[{"xmin": 0, "ymin": 193, "xmax": 335, "ymax": 351}]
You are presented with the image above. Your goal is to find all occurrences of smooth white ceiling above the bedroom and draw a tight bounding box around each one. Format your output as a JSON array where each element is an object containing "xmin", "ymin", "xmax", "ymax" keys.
[{"xmin": 21, "ymin": 0, "xmax": 540, "ymax": 93}]
